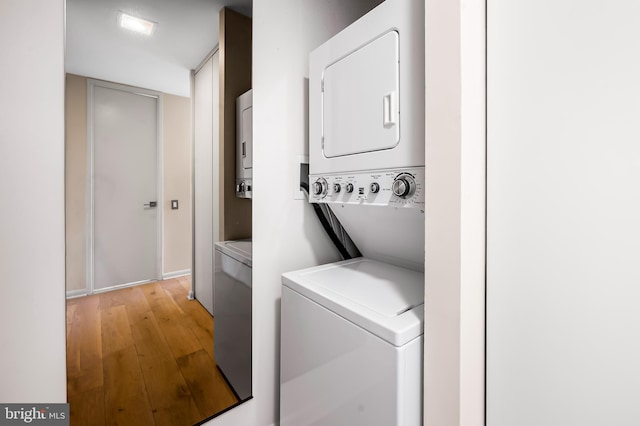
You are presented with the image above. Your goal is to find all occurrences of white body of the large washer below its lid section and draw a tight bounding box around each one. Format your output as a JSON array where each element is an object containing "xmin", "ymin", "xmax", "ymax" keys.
[{"xmin": 280, "ymin": 287, "xmax": 423, "ymax": 426}]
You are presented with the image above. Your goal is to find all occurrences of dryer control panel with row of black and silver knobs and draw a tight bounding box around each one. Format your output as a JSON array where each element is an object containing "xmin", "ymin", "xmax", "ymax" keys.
[{"xmin": 309, "ymin": 167, "xmax": 425, "ymax": 208}]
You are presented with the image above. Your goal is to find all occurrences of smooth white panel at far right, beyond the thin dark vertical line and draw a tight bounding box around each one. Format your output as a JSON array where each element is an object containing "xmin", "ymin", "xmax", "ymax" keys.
[{"xmin": 487, "ymin": 0, "xmax": 640, "ymax": 426}]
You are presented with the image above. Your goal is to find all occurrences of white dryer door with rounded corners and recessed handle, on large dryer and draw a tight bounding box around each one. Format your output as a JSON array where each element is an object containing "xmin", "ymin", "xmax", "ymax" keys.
[{"xmin": 322, "ymin": 31, "xmax": 400, "ymax": 157}]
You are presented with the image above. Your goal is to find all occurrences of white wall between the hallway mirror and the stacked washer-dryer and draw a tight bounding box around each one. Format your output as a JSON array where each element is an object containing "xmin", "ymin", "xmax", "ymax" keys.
[{"xmin": 210, "ymin": 0, "xmax": 376, "ymax": 426}]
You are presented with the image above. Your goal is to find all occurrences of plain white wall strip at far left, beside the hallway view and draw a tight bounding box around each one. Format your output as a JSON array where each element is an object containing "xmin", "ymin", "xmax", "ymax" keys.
[{"xmin": 0, "ymin": 0, "xmax": 66, "ymax": 403}]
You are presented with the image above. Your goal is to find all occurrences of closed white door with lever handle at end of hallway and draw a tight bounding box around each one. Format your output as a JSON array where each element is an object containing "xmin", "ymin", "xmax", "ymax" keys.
[{"xmin": 89, "ymin": 81, "xmax": 161, "ymax": 291}]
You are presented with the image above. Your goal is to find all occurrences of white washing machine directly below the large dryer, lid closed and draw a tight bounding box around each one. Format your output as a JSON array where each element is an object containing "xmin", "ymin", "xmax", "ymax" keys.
[{"xmin": 280, "ymin": 258, "xmax": 424, "ymax": 426}]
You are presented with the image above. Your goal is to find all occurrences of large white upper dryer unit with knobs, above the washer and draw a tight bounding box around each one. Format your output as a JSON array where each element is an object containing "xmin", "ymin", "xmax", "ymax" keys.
[{"xmin": 309, "ymin": 0, "xmax": 426, "ymax": 270}]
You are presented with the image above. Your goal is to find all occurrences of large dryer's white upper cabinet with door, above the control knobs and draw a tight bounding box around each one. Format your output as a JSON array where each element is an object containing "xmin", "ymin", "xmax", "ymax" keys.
[{"xmin": 309, "ymin": 0, "xmax": 425, "ymax": 174}]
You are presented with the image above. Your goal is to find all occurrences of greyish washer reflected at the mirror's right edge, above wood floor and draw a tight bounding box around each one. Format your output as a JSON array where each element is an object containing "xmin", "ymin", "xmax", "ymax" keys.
[{"xmin": 213, "ymin": 241, "xmax": 252, "ymax": 400}]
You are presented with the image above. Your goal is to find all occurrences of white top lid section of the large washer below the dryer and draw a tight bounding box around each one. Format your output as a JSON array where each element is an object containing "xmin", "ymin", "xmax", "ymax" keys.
[{"xmin": 282, "ymin": 258, "xmax": 424, "ymax": 346}]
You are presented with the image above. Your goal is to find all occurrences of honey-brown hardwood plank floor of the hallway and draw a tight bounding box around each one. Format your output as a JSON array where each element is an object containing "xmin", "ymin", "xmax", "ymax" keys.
[{"xmin": 67, "ymin": 277, "xmax": 238, "ymax": 426}]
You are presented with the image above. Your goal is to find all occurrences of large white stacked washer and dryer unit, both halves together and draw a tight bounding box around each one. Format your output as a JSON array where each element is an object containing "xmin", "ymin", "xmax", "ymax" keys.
[{"xmin": 280, "ymin": 0, "xmax": 425, "ymax": 426}]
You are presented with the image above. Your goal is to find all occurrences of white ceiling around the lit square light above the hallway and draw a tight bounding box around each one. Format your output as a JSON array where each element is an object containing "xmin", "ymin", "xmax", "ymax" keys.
[{"xmin": 65, "ymin": 0, "xmax": 252, "ymax": 96}]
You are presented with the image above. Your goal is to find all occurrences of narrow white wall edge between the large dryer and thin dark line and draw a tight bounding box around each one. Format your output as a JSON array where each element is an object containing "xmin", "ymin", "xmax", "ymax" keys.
[{"xmin": 424, "ymin": 0, "xmax": 485, "ymax": 426}]
